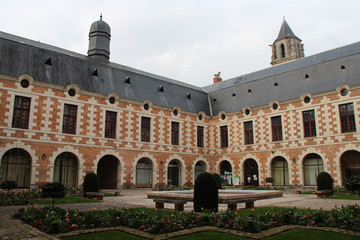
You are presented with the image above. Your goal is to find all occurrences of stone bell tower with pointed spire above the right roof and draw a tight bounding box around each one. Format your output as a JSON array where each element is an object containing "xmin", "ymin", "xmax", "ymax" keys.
[{"xmin": 270, "ymin": 17, "xmax": 305, "ymax": 66}]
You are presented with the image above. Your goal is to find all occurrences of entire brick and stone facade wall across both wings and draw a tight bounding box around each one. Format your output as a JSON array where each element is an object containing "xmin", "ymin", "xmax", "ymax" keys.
[{"xmin": 0, "ymin": 72, "xmax": 360, "ymax": 188}]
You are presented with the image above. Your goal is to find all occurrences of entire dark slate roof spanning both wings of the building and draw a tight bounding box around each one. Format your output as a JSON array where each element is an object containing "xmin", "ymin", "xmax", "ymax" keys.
[{"xmin": 0, "ymin": 29, "xmax": 360, "ymax": 115}]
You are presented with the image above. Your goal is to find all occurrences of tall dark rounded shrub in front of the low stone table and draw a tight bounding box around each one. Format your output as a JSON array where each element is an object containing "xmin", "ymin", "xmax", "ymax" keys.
[{"xmin": 194, "ymin": 172, "xmax": 219, "ymax": 212}]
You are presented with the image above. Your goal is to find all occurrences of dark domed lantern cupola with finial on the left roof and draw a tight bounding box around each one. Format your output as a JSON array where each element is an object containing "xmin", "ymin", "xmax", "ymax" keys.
[{"xmin": 88, "ymin": 15, "xmax": 111, "ymax": 63}]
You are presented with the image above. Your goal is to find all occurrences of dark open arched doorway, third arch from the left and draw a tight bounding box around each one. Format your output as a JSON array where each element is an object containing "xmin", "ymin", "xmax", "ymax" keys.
[{"xmin": 97, "ymin": 155, "xmax": 119, "ymax": 189}]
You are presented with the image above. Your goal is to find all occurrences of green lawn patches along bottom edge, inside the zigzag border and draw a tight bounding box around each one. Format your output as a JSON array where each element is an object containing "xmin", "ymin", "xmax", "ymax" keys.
[{"xmin": 61, "ymin": 228, "xmax": 358, "ymax": 240}]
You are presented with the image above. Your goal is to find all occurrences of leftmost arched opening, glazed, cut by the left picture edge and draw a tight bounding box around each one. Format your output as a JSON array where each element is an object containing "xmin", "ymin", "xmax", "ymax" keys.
[{"xmin": 0, "ymin": 148, "xmax": 31, "ymax": 188}]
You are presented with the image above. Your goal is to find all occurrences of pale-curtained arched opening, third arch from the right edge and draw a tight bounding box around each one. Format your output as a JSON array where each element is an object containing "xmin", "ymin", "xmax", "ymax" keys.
[{"xmin": 271, "ymin": 157, "xmax": 289, "ymax": 186}]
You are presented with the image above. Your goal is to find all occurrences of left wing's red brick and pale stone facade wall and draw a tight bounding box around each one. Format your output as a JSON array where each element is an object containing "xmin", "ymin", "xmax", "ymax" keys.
[{"xmin": 0, "ymin": 75, "xmax": 211, "ymax": 188}]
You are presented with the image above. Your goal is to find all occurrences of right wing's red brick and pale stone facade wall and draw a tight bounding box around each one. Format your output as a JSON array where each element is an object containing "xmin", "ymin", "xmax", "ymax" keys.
[{"xmin": 212, "ymin": 85, "xmax": 360, "ymax": 185}]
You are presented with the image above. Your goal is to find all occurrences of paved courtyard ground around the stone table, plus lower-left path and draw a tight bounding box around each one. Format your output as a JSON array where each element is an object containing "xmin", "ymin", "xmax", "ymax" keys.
[{"xmin": 0, "ymin": 189, "xmax": 360, "ymax": 240}]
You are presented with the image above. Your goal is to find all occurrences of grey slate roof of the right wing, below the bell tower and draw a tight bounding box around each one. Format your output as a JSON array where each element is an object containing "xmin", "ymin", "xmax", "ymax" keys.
[{"xmin": 204, "ymin": 42, "xmax": 360, "ymax": 115}]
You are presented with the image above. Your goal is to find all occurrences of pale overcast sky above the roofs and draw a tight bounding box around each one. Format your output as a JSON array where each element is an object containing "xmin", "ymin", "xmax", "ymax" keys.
[{"xmin": 0, "ymin": 0, "xmax": 360, "ymax": 87}]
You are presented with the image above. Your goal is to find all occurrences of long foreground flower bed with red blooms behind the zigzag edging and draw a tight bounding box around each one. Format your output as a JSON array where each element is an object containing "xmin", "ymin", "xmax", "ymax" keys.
[{"xmin": 14, "ymin": 205, "xmax": 360, "ymax": 234}]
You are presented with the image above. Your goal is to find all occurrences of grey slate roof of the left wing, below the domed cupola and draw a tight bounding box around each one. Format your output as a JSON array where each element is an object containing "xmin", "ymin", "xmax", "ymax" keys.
[{"xmin": 0, "ymin": 32, "xmax": 210, "ymax": 115}]
